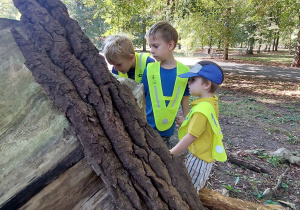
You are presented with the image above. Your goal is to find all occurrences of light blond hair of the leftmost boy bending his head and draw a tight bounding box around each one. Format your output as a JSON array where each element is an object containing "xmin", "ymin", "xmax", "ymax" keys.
[{"xmin": 103, "ymin": 35, "xmax": 135, "ymax": 63}]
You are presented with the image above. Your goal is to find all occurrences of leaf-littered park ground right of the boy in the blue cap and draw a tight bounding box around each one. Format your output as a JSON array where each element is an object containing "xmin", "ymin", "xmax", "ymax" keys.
[{"xmin": 173, "ymin": 51, "xmax": 300, "ymax": 209}]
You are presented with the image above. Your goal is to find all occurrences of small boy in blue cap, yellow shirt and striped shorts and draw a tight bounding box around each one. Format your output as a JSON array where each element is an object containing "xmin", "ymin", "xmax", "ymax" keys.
[{"xmin": 170, "ymin": 61, "xmax": 227, "ymax": 192}]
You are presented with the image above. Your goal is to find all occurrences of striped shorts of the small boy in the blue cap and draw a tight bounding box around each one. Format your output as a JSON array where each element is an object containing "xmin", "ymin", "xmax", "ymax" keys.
[{"xmin": 185, "ymin": 152, "xmax": 213, "ymax": 192}]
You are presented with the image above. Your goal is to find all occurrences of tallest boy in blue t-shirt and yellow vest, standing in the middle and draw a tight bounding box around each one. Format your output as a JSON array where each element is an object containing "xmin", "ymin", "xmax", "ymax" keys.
[{"xmin": 142, "ymin": 22, "xmax": 189, "ymax": 149}]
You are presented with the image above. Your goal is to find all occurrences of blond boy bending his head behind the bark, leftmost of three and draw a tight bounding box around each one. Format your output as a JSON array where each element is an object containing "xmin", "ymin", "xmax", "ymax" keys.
[{"xmin": 103, "ymin": 35, "xmax": 155, "ymax": 83}]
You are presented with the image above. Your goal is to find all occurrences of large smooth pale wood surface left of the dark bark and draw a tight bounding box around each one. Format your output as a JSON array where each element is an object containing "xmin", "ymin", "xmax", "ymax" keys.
[{"xmin": 0, "ymin": 18, "xmax": 86, "ymax": 209}]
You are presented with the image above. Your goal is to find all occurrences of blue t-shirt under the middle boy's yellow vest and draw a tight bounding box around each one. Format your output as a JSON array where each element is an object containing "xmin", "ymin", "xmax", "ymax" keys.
[{"xmin": 141, "ymin": 67, "xmax": 190, "ymax": 136}]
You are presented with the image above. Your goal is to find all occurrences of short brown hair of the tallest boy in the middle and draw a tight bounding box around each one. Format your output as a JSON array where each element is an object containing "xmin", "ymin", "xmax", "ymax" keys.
[{"xmin": 145, "ymin": 21, "xmax": 178, "ymax": 46}]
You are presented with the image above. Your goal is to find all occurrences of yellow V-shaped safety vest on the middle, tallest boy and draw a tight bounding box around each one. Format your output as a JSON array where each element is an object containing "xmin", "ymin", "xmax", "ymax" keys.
[{"xmin": 147, "ymin": 62, "xmax": 190, "ymax": 131}]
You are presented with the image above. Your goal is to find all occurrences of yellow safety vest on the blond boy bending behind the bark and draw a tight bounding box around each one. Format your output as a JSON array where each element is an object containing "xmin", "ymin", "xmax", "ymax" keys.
[{"xmin": 118, "ymin": 53, "xmax": 150, "ymax": 83}]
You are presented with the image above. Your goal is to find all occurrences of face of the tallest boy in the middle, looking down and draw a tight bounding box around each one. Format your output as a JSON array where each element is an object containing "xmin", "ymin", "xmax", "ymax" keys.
[{"xmin": 147, "ymin": 34, "xmax": 175, "ymax": 61}]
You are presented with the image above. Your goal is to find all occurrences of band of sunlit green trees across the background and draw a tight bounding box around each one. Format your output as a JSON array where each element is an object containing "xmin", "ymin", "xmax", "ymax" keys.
[{"xmin": 0, "ymin": 0, "xmax": 300, "ymax": 65}]
